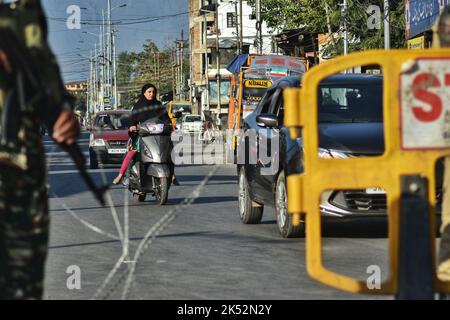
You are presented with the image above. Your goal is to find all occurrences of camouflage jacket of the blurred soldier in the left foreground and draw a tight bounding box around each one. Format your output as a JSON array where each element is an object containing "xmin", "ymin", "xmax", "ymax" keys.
[{"xmin": 0, "ymin": 0, "xmax": 66, "ymax": 171}]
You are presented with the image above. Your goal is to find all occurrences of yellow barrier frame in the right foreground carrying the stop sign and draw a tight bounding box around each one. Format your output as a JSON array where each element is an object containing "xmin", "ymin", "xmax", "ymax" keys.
[{"xmin": 284, "ymin": 49, "xmax": 450, "ymax": 294}]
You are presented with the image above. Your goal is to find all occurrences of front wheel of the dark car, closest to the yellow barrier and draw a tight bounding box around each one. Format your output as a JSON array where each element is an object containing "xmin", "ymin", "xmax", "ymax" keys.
[{"xmin": 275, "ymin": 171, "xmax": 305, "ymax": 238}]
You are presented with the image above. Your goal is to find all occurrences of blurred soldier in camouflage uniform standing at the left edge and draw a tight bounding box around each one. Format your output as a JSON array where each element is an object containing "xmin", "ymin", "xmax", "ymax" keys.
[{"xmin": 0, "ymin": 0, "xmax": 79, "ymax": 299}]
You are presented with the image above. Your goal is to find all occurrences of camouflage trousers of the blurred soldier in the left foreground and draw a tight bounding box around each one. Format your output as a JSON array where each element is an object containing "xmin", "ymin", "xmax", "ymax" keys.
[{"xmin": 0, "ymin": 165, "xmax": 49, "ymax": 299}]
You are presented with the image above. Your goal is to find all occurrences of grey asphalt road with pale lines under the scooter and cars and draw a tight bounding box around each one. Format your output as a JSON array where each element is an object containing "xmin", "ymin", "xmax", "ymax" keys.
[{"xmin": 45, "ymin": 133, "xmax": 392, "ymax": 300}]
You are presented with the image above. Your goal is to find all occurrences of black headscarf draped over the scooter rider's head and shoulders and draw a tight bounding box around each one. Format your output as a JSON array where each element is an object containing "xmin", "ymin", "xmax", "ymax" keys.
[{"xmin": 131, "ymin": 83, "xmax": 170, "ymax": 125}]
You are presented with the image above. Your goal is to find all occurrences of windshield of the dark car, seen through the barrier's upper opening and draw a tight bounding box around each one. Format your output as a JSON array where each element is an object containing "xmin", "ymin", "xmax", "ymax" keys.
[{"xmin": 318, "ymin": 83, "xmax": 383, "ymax": 123}]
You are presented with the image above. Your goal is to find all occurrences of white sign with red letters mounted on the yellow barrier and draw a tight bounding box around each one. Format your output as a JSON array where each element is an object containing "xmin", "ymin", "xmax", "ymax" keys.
[{"xmin": 400, "ymin": 58, "xmax": 450, "ymax": 149}]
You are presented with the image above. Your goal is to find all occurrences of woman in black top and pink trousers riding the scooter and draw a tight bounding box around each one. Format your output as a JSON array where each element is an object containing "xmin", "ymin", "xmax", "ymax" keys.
[{"xmin": 113, "ymin": 84, "xmax": 180, "ymax": 186}]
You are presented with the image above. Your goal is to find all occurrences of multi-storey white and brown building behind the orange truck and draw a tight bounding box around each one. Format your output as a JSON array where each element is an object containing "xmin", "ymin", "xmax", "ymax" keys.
[{"xmin": 189, "ymin": 0, "xmax": 276, "ymax": 123}]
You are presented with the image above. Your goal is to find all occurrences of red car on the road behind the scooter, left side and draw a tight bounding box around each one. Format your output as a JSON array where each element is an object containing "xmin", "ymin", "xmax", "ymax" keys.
[{"xmin": 89, "ymin": 110, "xmax": 131, "ymax": 169}]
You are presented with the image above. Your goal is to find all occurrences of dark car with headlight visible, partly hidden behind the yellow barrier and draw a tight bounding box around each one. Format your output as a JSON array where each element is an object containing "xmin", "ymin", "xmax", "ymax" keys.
[{"xmin": 238, "ymin": 74, "xmax": 442, "ymax": 237}]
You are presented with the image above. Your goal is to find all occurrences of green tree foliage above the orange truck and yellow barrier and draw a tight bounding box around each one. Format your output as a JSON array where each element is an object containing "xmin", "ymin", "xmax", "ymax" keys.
[{"xmin": 249, "ymin": 0, "xmax": 405, "ymax": 56}]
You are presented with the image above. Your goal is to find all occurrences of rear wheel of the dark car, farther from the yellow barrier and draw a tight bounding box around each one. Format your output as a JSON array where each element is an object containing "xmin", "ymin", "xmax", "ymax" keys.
[{"xmin": 239, "ymin": 167, "xmax": 264, "ymax": 224}]
